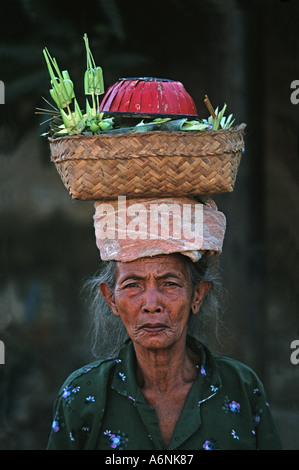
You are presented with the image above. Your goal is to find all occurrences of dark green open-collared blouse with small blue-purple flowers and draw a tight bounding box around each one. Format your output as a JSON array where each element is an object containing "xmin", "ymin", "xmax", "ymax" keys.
[{"xmin": 48, "ymin": 341, "xmax": 282, "ymax": 451}]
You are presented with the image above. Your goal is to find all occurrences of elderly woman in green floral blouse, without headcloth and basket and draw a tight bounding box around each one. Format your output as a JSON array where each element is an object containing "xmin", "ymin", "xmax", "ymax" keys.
[{"xmin": 48, "ymin": 196, "xmax": 281, "ymax": 450}]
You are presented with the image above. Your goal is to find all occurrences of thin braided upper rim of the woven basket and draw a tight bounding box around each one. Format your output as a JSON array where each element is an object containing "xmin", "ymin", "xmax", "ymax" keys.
[{"xmin": 48, "ymin": 123, "xmax": 246, "ymax": 143}]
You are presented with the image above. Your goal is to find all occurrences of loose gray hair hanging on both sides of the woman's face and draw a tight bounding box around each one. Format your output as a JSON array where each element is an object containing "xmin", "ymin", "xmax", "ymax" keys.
[{"xmin": 84, "ymin": 255, "xmax": 223, "ymax": 359}]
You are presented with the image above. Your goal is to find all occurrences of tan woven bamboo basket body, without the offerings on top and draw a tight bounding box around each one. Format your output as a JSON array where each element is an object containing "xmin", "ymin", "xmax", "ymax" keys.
[{"xmin": 49, "ymin": 124, "xmax": 245, "ymax": 200}]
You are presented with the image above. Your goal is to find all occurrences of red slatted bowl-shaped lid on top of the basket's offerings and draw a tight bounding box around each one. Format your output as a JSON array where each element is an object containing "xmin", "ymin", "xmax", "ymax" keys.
[{"xmin": 100, "ymin": 77, "xmax": 197, "ymax": 117}]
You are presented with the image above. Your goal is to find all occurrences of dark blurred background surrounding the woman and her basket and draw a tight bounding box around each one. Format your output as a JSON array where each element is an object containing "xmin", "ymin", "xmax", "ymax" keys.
[{"xmin": 0, "ymin": 0, "xmax": 299, "ymax": 449}]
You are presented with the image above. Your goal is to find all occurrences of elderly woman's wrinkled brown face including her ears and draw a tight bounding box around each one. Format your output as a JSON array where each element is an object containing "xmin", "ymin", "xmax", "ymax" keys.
[{"xmin": 100, "ymin": 254, "xmax": 209, "ymax": 349}]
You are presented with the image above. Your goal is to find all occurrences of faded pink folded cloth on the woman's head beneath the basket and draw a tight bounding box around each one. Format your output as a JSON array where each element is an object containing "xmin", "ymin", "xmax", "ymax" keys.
[{"xmin": 94, "ymin": 196, "xmax": 226, "ymax": 262}]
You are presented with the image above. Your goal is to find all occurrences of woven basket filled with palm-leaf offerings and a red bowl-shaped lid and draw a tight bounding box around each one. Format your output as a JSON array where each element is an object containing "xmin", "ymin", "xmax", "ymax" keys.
[{"xmin": 38, "ymin": 35, "xmax": 245, "ymax": 200}]
